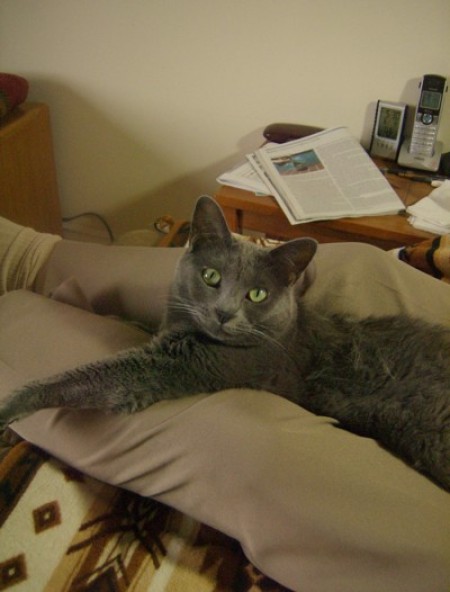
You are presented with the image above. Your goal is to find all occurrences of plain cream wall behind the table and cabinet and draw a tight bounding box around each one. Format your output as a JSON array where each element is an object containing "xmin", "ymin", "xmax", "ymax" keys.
[{"xmin": 0, "ymin": 0, "xmax": 450, "ymax": 238}]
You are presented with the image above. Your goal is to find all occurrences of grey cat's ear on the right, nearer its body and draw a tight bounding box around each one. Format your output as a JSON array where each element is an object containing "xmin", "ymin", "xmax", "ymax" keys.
[{"xmin": 269, "ymin": 238, "xmax": 317, "ymax": 286}]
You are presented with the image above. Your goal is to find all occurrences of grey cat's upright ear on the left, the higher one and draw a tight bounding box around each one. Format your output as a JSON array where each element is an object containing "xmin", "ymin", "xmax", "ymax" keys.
[{"xmin": 189, "ymin": 195, "xmax": 232, "ymax": 250}]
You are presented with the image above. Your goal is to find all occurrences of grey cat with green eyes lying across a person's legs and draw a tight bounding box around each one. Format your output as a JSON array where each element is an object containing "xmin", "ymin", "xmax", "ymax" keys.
[{"xmin": 0, "ymin": 197, "xmax": 450, "ymax": 491}]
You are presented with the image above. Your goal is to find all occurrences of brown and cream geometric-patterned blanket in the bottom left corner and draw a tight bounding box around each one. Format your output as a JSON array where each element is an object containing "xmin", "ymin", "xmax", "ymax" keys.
[{"xmin": 0, "ymin": 442, "xmax": 288, "ymax": 592}]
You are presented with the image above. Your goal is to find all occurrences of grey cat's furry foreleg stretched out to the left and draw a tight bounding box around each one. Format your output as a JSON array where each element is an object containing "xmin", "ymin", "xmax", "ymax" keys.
[{"xmin": 0, "ymin": 334, "xmax": 246, "ymax": 427}]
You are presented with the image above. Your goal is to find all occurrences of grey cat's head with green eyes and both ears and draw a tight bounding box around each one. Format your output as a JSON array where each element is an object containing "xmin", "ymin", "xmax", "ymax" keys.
[{"xmin": 167, "ymin": 196, "xmax": 317, "ymax": 345}]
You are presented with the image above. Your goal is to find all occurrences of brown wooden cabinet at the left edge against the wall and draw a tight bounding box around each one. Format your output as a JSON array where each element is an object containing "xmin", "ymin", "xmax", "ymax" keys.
[{"xmin": 0, "ymin": 103, "xmax": 62, "ymax": 234}]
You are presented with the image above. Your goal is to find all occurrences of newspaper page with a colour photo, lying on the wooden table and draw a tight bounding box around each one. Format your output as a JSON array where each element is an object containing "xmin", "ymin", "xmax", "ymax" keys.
[{"xmin": 247, "ymin": 127, "xmax": 404, "ymax": 224}]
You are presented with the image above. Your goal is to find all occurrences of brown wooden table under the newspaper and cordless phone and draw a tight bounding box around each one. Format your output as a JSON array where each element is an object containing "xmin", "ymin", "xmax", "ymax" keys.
[{"xmin": 215, "ymin": 162, "xmax": 435, "ymax": 250}]
